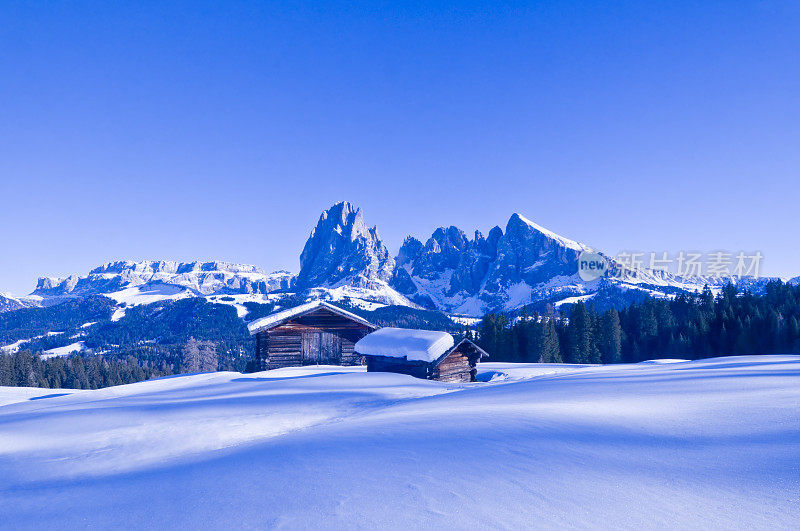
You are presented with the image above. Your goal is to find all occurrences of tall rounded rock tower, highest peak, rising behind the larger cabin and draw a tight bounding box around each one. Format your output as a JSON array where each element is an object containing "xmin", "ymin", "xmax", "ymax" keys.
[{"xmin": 297, "ymin": 201, "xmax": 394, "ymax": 289}]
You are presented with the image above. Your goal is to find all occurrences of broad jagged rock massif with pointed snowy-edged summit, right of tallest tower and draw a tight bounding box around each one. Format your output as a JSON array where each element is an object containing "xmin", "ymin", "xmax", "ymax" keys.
[{"xmin": 392, "ymin": 214, "xmax": 586, "ymax": 315}]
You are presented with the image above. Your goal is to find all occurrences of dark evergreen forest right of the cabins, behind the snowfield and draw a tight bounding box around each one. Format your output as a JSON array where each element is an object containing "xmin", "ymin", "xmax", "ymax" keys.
[{"xmin": 479, "ymin": 281, "xmax": 800, "ymax": 363}]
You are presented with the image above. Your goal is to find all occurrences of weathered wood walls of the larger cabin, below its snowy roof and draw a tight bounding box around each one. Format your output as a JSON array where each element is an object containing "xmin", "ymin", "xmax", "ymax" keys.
[{"xmin": 256, "ymin": 308, "xmax": 372, "ymax": 370}]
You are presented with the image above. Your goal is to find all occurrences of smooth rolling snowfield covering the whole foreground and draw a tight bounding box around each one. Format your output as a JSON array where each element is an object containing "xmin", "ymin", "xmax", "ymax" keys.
[{"xmin": 0, "ymin": 356, "xmax": 800, "ymax": 529}]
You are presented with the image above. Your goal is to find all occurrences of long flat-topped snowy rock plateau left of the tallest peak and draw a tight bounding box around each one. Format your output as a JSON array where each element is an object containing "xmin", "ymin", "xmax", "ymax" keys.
[{"xmin": 32, "ymin": 260, "xmax": 293, "ymax": 299}]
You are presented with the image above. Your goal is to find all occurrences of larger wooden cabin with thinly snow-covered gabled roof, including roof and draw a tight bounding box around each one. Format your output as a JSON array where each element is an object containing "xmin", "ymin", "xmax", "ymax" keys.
[{"xmin": 248, "ymin": 301, "xmax": 378, "ymax": 370}]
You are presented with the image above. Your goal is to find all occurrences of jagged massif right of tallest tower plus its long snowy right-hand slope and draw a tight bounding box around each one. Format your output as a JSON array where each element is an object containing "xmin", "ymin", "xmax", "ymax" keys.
[{"xmin": 391, "ymin": 214, "xmax": 768, "ymax": 316}]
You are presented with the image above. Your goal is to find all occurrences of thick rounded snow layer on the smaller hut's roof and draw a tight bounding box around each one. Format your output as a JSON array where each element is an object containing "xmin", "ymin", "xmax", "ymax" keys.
[{"xmin": 355, "ymin": 327, "xmax": 455, "ymax": 363}]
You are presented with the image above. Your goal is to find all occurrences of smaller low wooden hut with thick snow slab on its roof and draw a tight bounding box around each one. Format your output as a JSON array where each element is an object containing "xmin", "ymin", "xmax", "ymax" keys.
[{"xmin": 355, "ymin": 328, "xmax": 489, "ymax": 382}]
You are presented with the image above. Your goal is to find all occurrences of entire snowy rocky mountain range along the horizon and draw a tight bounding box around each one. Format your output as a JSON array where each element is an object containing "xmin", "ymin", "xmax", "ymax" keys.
[{"xmin": 0, "ymin": 201, "xmax": 788, "ymax": 317}]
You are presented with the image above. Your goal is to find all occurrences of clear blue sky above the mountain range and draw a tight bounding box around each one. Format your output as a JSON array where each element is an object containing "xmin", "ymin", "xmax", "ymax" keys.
[{"xmin": 0, "ymin": 0, "xmax": 800, "ymax": 294}]
